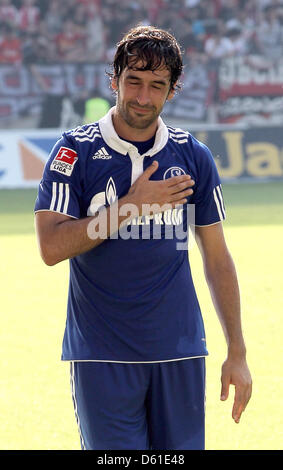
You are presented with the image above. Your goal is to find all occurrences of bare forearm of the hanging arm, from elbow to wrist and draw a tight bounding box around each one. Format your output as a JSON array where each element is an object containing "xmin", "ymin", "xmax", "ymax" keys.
[{"xmin": 205, "ymin": 252, "xmax": 246, "ymax": 355}]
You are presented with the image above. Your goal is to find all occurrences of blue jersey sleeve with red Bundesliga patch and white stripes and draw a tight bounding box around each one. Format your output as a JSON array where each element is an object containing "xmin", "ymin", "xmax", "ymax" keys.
[{"xmin": 34, "ymin": 134, "xmax": 81, "ymax": 219}]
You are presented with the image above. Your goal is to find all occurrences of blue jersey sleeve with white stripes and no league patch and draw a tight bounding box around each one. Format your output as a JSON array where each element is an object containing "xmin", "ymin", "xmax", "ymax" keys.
[{"xmin": 191, "ymin": 141, "xmax": 226, "ymax": 225}]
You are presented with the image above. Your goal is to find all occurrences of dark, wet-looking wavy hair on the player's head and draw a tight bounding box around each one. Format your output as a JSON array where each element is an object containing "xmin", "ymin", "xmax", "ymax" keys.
[{"xmin": 109, "ymin": 26, "xmax": 183, "ymax": 90}]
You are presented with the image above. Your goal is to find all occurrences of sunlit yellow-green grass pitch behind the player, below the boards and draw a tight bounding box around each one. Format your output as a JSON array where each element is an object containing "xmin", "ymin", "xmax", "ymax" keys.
[{"xmin": 0, "ymin": 183, "xmax": 283, "ymax": 450}]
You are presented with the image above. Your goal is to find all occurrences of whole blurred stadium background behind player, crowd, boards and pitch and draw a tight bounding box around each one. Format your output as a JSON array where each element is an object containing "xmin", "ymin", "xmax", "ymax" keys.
[{"xmin": 0, "ymin": 0, "xmax": 283, "ymax": 449}]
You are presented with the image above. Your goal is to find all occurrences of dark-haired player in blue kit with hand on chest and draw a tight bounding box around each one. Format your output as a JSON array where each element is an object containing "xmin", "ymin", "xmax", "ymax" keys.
[{"xmin": 35, "ymin": 27, "xmax": 254, "ymax": 450}]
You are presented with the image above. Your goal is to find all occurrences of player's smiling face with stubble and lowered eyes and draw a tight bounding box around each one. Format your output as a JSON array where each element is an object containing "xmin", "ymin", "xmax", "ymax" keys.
[{"xmin": 112, "ymin": 63, "xmax": 174, "ymax": 129}]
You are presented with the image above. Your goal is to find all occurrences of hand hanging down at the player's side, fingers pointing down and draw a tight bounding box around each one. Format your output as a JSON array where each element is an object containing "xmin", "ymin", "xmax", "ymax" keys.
[{"xmin": 221, "ymin": 356, "xmax": 252, "ymax": 423}]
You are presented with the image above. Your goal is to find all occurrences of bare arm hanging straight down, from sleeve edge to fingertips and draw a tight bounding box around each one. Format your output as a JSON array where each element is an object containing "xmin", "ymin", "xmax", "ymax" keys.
[{"xmin": 195, "ymin": 223, "xmax": 252, "ymax": 423}]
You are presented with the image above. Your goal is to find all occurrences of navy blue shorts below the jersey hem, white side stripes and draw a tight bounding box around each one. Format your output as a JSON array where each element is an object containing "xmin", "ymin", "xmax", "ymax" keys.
[{"xmin": 71, "ymin": 357, "xmax": 205, "ymax": 450}]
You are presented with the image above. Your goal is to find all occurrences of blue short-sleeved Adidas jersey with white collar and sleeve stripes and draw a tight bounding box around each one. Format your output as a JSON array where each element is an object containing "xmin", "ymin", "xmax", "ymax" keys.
[{"xmin": 35, "ymin": 108, "xmax": 225, "ymax": 362}]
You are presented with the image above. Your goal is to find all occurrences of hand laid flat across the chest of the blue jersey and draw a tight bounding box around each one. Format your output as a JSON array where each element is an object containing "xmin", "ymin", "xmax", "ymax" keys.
[{"xmin": 128, "ymin": 161, "xmax": 195, "ymax": 212}]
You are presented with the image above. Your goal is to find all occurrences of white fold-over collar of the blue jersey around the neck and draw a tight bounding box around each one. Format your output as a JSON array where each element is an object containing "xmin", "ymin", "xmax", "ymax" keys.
[{"xmin": 98, "ymin": 106, "xmax": 168, "ymax": 157}]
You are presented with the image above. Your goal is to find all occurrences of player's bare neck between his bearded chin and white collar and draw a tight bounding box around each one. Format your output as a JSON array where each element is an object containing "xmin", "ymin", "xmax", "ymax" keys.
[{"xmin": 112, "ymin": 106, "xmax": 158, "ymax": 142}]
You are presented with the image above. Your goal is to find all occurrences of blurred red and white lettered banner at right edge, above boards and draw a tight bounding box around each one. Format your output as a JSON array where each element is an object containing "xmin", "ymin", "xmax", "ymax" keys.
[{"xmin": 218, "ymin": 56, "xmax": 283, "ymax": 123}]
